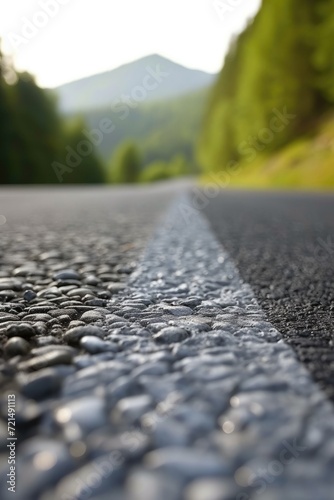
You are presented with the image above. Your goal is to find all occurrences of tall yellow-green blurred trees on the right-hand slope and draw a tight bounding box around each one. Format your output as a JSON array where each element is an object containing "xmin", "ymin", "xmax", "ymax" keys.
[{"xmin": 198, "ymin": 0, "xmax": 334, "ymax": 172}]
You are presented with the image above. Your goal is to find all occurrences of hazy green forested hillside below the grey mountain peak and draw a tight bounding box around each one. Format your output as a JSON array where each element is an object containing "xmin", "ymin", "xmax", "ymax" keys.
[{"xmin": 78, "ymin": 88, "xmax": 209, "ymax": 167}]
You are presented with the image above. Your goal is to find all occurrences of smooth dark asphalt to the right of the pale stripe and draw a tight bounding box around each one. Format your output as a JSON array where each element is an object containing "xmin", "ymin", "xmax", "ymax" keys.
[{"xmin": 201, "ymin": 190, "xmax": 334, "ymax": 400}]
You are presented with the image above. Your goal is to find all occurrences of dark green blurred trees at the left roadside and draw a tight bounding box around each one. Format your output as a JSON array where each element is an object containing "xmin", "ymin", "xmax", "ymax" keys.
[{"xmin": 0, "ymin": 42, "xmax": 104, "ymax": 184}]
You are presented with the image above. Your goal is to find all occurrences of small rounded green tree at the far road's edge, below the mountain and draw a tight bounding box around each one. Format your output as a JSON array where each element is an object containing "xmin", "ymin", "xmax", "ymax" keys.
[{"xmin": 109, "ymin": 141, "xmax": 142, "ymax": 184}]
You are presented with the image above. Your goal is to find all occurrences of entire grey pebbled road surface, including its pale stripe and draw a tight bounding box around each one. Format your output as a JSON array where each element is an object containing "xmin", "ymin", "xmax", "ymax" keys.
[{"xmin": 0, "ymin": 182, "xmax": 334, "ymax": 500}]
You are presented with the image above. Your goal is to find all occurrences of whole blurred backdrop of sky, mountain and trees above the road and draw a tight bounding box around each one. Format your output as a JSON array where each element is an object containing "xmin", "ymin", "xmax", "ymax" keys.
[{"xmin": 0, "ymin": 0, "xmax": 334, "ymax": 189}]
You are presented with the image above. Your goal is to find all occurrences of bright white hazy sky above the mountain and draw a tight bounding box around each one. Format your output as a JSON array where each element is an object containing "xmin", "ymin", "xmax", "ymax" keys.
[{"xmin": 0, "ymin": 0, "xmax": 261, "ymax": 87}]
